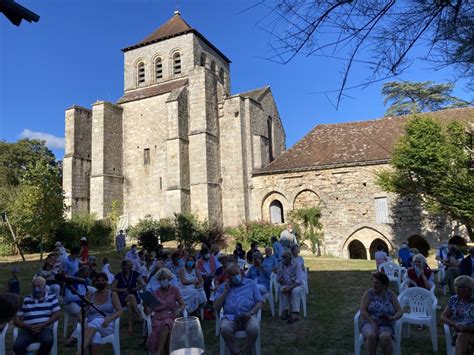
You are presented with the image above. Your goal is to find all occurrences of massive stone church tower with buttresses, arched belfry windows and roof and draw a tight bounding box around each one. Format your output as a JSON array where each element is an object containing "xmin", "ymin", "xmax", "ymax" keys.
[{"xmin": 64, "ymin": 14, "xmax": 285, "ymax": 225}]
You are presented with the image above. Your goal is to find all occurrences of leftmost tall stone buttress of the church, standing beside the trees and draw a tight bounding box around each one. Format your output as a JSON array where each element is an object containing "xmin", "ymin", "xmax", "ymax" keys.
[{"xmin": 63, "ymin": 105, "xmax": 92, "ymax": 217}]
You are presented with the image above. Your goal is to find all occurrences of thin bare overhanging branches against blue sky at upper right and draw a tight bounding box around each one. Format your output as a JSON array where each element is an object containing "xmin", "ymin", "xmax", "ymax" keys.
[{"xmin": 259, "ymin": 0, "xmax": 474, "ymax": 104}]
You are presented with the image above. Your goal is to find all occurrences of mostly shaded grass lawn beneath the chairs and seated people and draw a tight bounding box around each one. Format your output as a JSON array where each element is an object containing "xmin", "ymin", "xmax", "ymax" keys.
[{"xmin": 0, "ymin": 250, "xmax": 447, "ymax": 355}]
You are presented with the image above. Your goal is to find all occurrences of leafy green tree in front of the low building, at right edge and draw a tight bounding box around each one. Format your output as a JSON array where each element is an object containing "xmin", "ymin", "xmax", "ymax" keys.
[{"xmin": 377, "ymin": 115, "xmax": 474, "ymax": 241}]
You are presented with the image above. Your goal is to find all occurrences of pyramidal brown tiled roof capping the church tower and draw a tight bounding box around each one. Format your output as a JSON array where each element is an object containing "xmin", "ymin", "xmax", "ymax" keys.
[{"xmin": 122, "ymin": 11, "xmax": 230, "ymax": 63}]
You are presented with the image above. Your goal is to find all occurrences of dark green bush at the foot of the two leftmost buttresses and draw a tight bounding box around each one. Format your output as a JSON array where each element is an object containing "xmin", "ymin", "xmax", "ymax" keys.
[{"xmin": 54, "ymin": 212, "xmax": 113, "ymax": 248}]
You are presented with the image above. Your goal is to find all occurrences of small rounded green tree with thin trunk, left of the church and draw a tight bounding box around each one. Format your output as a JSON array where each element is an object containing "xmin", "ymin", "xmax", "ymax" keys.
[{"xmin": 9, "ymin": 159, "xmax": 65, "ymax": 259}]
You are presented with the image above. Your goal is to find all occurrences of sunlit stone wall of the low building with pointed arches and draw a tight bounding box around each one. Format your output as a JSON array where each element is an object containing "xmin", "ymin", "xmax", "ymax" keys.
[{"xmin": 251, "ymin": 165, "xmax": 459, "ymax": 257}]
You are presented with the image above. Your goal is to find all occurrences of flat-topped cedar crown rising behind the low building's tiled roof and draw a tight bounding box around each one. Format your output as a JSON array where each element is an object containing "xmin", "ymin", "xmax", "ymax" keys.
[{"xmin": 382, "ymin": 81, "xmax": 469, "ymax": 116}]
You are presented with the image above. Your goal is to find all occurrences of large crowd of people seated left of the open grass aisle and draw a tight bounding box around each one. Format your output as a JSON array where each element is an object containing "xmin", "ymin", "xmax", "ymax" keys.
[{"xmin": 1, "ymin": 227, "xmax": 305, "ymax": 354}]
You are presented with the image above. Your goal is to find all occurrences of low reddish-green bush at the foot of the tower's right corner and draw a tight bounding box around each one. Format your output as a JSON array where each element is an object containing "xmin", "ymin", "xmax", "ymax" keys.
[{"xmin": 226, "ymin": 222, "xmax": 285, "ymax": 249}]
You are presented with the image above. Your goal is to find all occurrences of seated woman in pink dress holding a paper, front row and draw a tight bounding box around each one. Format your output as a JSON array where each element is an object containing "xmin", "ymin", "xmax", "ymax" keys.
[{"xmin": 147, "ymin": 268, "xmax": 185, "ymax": 355}]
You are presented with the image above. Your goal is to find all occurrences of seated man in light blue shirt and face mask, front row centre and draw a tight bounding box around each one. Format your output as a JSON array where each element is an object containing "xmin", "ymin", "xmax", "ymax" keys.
[{"xmin": 214, "ymin": 263, "xmax": 263, "ymax": 354}]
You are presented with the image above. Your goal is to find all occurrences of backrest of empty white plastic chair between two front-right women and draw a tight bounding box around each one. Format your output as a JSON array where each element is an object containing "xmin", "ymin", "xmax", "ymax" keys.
[{"xmin": 398, "ymin": 287, "xmax": 438, "ymax": 317}]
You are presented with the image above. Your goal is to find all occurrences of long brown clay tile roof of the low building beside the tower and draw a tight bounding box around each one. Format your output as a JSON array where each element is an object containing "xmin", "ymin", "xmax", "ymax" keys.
[{"xmin": 255, "ymin": 107, "xmax": 474, "ymax": 174}]
